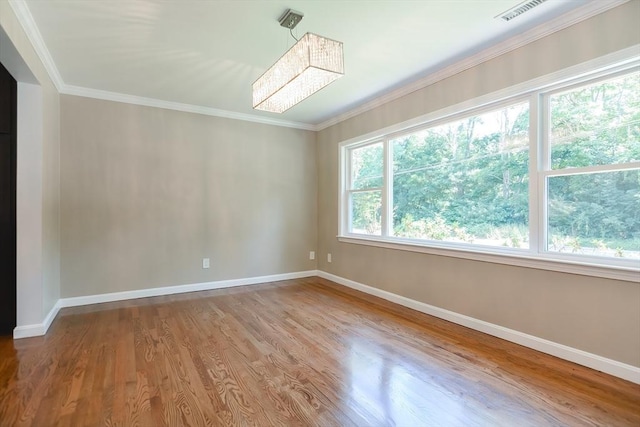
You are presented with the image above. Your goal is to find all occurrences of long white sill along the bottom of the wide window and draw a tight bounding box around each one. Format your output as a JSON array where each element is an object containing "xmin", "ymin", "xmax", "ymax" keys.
[{"xmin": 337, "ymin": 235, "xmax": 640, "ymax": 283}]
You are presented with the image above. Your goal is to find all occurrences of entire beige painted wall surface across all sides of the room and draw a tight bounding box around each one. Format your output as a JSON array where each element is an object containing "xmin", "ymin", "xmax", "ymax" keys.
[{"xmin": 0, "ymin": 0, "xmax": 640, "ymax": 372}]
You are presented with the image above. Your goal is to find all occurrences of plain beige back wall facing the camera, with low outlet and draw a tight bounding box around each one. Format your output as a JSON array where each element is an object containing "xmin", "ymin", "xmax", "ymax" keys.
[{"xmin": 60, "ymin": 95, "xmax": 317, "ymax": 297}]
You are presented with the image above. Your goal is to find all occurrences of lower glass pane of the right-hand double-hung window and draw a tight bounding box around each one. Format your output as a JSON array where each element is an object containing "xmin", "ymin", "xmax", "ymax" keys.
[{"xmin": 547, "ymin": 170, "xmax": 640, "ymax": 258}]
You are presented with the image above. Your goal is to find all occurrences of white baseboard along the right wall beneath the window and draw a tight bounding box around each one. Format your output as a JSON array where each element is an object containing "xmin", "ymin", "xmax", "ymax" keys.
[{"xmin": 318, "ymin": 271, "xmax": 640, "ymax": 384}]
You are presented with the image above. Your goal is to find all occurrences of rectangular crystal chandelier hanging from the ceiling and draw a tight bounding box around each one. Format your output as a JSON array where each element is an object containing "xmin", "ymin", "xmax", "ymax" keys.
[{"xmin": 253, "ymin": 10, "xmax": 344, "ymax": 113}]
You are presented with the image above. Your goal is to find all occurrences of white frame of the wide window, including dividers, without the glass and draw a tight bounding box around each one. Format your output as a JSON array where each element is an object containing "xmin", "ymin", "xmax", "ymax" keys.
[{"xmin": 337, "ymin": 47, "xmax": 640, "ymax": 282}]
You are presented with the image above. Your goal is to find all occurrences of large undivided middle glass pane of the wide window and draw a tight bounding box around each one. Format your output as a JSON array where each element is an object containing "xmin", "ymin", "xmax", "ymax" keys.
[{"xmin": 391, "ymin": 103, "xmax": 529, "ymax": 248}]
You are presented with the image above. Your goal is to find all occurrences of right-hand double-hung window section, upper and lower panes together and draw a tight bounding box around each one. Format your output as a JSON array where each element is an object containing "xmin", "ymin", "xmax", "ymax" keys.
[{"xmin": 543, "ymin": 71, "xmax": 640, "ymax": 259}]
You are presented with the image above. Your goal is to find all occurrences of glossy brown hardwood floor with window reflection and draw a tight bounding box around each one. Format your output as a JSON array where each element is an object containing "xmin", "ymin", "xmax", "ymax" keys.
[{"xmin": 0, "ymin": 278, "xmax": 640, "ymax": 427}]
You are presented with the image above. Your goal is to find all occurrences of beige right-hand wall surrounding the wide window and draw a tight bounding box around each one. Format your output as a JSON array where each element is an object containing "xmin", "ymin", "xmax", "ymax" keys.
[{"xmin": 318, "ymin": 1, "xmax": 640, "ymax": 366}]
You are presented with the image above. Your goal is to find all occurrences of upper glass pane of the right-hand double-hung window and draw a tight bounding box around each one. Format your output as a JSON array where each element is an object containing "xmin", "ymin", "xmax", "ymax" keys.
[{"xmin": 550, "ymin": 72, "xmax": 640, "ymax": 169}]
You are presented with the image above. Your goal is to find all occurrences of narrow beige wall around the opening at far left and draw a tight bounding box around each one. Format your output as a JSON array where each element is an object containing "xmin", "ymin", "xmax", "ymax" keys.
[{"xmin": 0, "ymin": 0, "xmax": 60, "ymax": 327}]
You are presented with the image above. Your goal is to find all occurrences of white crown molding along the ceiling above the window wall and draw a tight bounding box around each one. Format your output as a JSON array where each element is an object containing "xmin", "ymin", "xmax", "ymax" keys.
[{"xmin": 315, "ymin": 0, "xmax": 629, "ymax": 131}]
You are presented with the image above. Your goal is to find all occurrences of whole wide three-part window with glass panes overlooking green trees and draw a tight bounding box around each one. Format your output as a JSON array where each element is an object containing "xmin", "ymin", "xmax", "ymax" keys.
[{"xmin": 340, "ymin": 59, "xmax": 640, "ymax": 278}]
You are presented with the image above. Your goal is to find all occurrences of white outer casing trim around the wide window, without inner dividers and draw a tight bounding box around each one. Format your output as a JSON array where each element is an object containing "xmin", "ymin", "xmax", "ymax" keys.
[{"xmin": 336, "ymin": 51, "xmax": 640, "ymax": 283}]
